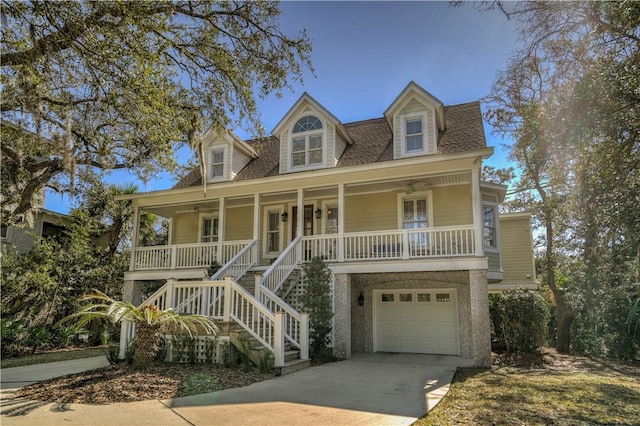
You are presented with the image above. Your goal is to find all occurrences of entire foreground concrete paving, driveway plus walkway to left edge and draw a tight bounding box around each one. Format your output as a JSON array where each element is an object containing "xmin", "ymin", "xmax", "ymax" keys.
[{"xmin": 1, "ymin": 353, "xmax": 471, "ymax": 426}]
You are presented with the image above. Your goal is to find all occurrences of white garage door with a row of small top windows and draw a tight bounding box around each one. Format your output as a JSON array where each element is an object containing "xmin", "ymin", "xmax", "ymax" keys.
[{"xmin": 373, "ymin": 290, "xmax": 459, "ymax": 355}]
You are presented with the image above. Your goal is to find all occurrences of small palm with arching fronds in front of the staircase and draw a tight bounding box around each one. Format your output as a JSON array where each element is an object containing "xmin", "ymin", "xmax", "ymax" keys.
[{"xmin": 61, "ymin": 289, "xmax": 218, "ymax": 368}]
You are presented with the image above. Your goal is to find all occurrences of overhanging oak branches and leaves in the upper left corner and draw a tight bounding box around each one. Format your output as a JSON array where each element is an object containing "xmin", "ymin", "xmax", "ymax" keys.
[{"xmin": 0, "ymin": 0, "xmax": 311, "ymax": 224}]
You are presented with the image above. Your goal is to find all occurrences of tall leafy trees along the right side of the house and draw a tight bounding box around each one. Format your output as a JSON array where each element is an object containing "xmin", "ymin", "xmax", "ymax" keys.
[{"xmin": 480, "ymin": 1, "xmax": 640, "ymax": 356}]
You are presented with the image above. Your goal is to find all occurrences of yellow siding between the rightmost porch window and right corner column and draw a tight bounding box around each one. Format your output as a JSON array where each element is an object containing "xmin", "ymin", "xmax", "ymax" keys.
[{"xmin": 432, "ymin": 185, "xmax": 473, "ymax": 226}]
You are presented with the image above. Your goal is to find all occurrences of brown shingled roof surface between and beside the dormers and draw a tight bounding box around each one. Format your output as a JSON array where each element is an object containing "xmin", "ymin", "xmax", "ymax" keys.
[{"xmin": 174, "ymin": 101, "xmax": 487, "ymax": 188}]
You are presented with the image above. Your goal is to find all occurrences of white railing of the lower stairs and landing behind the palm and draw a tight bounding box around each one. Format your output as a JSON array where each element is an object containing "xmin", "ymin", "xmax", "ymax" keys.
[{"xmin": 120, "ymin": 277, "xmax": 309, "ymax": 366}]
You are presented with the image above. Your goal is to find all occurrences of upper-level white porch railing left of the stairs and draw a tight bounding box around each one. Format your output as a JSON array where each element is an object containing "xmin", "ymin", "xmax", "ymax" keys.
[{"xmin": 131, "ymin": 240, "xmax": 251, "ymax": 271}]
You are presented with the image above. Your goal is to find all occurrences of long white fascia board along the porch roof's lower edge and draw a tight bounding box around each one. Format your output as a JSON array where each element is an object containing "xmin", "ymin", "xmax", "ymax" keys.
[{"xmin": 115, "ymin": 147, "xmax": 493, "ymax": 201}]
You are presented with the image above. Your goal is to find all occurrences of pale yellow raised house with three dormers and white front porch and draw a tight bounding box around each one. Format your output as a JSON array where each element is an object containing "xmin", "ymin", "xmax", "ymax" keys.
[{"xmin": 120, "ymin": 82, "xmax": 535, "ymax": 366}]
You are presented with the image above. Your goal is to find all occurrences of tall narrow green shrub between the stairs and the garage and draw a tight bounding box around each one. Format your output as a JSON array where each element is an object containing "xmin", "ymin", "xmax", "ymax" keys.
[{"xmin": 302, "ymin": 257, "xmax": 333, "ymax": 362}]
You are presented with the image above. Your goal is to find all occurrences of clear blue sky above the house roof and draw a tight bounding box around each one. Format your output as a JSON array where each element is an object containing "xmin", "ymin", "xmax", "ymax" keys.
[{"xmin": 46, "ymin": 1, "xmax": 517, "ymax": 213}]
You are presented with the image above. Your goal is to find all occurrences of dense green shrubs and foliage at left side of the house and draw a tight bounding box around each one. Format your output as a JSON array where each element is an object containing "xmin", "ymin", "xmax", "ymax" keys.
[{"xmin": 0, "ymin": 185, "xmax": 155, "ymax": 348}]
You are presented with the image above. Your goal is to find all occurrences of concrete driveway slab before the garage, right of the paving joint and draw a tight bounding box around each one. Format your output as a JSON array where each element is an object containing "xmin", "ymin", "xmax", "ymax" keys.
[{"xmin": 165, "ymin": 353, "xmax": 472, "ymax": 425}]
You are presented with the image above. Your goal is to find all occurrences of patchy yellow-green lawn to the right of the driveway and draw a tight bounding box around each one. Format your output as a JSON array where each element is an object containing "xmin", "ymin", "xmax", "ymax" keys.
[{"xmin": 415, "ymin": 368, "xmax": 640, "ymax": 426}]
